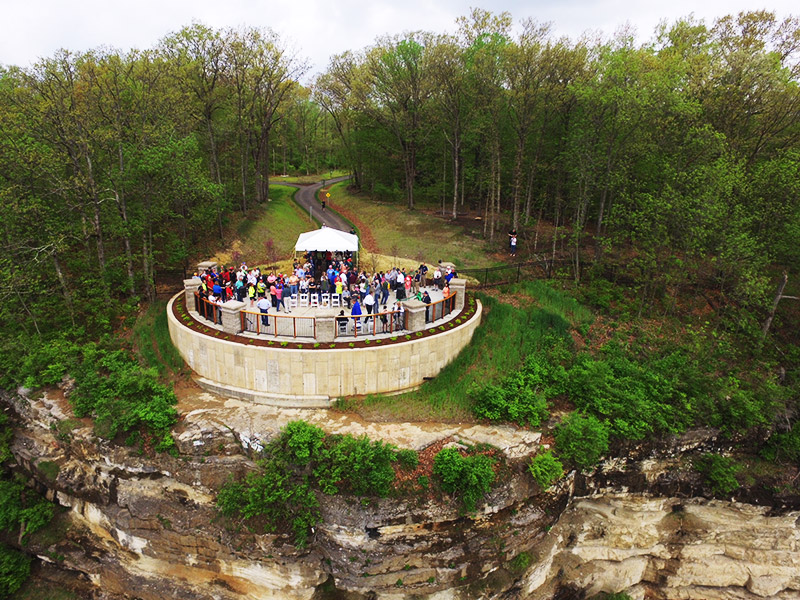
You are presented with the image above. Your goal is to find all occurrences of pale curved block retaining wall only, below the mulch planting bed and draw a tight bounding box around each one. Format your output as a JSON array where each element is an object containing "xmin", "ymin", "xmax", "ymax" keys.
[{"xmin": 167, "ymin": 296, "xmax": 483, "ymax": 406}]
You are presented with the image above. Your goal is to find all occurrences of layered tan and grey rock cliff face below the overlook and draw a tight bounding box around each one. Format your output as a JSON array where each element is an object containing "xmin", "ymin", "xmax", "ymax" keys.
[{"xmin": 4, "ymin": 390, "xmax": 800, "ymax": 600}]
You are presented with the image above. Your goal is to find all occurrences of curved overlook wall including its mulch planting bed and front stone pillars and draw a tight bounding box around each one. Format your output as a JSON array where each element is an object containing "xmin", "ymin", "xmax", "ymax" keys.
[{"xmin": 167, "ymin": 280, "xmax": 482, "ymax": 408}]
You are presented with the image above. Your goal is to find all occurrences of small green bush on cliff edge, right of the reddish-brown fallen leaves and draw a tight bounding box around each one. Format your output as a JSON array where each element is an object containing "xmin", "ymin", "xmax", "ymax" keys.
[{"xmin": 433, "ymin": 448, "xmax": 495, "ymax": 512}]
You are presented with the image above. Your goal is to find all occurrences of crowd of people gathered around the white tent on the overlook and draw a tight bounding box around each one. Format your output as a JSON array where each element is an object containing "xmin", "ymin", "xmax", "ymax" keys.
[{"xmin": 194, "ymin": 252, "xmax": 456, "ymax": 332}]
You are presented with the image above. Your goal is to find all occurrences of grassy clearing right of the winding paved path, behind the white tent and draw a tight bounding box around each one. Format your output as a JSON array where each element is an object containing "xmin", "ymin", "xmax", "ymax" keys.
[{"xmin": 331, "ymin": 181, "xmax": 496, "ymax": 268}]
